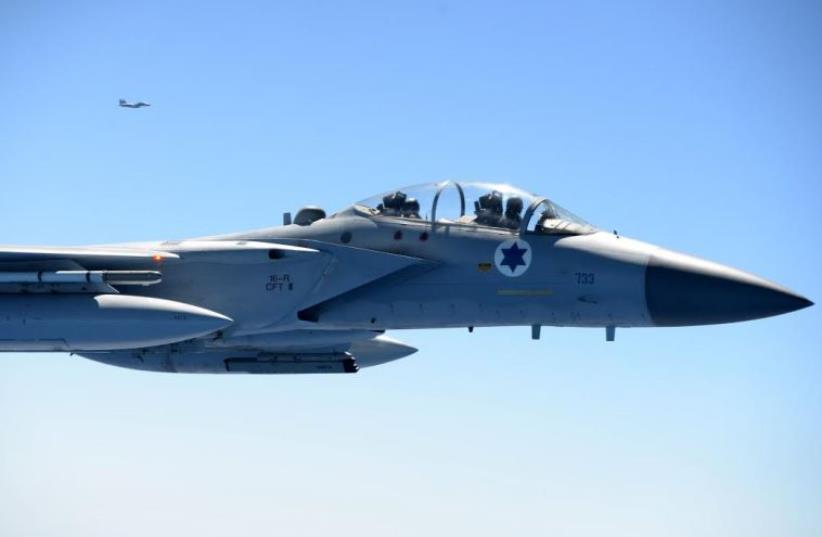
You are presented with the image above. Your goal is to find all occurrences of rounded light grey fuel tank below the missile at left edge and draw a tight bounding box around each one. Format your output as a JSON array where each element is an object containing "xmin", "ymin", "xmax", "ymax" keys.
[{"xmin": 0, "ymin": 294, "xmax": 232, "ymax": 351}]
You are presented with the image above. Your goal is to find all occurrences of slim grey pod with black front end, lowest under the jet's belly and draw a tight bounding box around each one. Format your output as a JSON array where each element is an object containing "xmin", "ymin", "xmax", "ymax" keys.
[{"xmin": 225, "ymin": 353, "xmax": 359, "ymax": 375}]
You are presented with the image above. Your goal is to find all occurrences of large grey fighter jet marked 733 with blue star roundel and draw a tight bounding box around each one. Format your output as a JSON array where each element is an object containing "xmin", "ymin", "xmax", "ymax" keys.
[{"xmin": 0, "ymin": 181, "xmax": 812, "ymax": 374}]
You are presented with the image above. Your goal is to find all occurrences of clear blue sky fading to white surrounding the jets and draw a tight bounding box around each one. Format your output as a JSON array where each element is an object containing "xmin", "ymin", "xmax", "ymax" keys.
[{"xmin": 0, "ymin": 0, "xmax": 822, "ymax": 537}]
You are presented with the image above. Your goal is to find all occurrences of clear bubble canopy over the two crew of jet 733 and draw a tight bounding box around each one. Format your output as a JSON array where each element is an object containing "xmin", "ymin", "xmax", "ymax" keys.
[{"xmin": 338, "ymin": 181, "xmax": 596, "ymax": 235}]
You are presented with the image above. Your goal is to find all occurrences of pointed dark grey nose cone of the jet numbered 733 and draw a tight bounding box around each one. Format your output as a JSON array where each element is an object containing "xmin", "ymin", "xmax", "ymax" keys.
[{"xmin": 645, "ymin": 252, "xmax": 813, "ymax": 326}]
